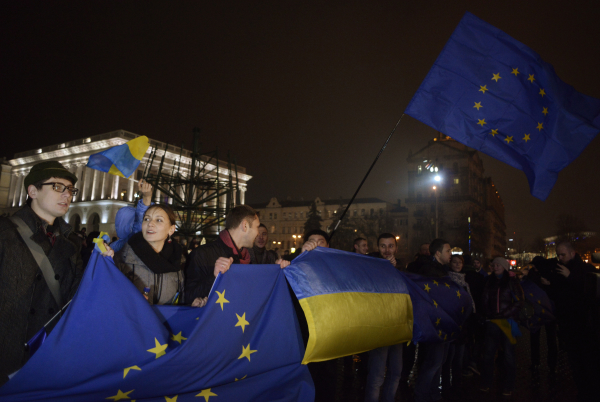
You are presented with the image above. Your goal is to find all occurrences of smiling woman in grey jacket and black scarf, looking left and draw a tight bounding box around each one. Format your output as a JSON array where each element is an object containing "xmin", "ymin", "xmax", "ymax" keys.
[{"xmin": 114, "ymin": 204, "xmax": 183, "ymax": 304}]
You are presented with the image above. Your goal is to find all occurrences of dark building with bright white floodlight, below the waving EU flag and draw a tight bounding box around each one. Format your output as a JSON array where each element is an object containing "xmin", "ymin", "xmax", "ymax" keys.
[{"xmin": 406, "ymin": 133, "xmax": 506, "ymax": 258}]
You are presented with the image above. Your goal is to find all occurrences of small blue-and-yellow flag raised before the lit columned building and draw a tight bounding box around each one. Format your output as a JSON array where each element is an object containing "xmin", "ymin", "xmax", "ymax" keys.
[{"xmin": 87, "ymin": 135, "xmax": 150, "ymax": 177}]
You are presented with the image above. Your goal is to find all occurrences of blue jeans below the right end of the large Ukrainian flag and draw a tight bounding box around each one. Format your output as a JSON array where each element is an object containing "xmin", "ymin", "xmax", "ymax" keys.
[{"xmin": 365, "ymin": 344, "xmax": 404, "ymax": 402}]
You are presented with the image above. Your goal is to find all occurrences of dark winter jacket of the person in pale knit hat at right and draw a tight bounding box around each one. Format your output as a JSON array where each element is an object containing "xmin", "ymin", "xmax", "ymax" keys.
[{"xmin": 482, "ymin": 271, "xmax": 525, "ymax": 319}]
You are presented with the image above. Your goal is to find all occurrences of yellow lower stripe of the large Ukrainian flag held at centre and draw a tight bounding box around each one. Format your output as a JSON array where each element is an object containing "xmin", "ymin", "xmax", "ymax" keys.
[{"xmin": 300, "ymin": 292, "xmax": 413, "ymax": 364}]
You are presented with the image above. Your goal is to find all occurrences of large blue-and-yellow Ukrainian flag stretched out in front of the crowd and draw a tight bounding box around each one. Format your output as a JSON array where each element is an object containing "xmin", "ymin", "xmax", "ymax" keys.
[{"xmin": 283, "ymin": 247, "xmax": 413, "ymax": 364}]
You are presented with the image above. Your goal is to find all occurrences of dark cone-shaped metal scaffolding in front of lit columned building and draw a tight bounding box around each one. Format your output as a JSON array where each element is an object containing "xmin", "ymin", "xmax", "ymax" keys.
[{"xmin": 143, "ymin": 128, "xmax": 239, "ymax": 241}]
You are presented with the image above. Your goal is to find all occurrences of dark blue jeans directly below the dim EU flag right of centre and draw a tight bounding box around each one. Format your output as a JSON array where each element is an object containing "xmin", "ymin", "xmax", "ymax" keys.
[{"xmin": 415, "ymin": 343, "xmax": 449, "ymax": 402}]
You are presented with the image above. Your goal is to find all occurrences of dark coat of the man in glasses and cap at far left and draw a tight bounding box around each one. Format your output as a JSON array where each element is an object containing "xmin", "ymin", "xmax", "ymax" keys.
[{"xmin": 0, "ymin": 206, "xmax": 83, "ymax": 385}]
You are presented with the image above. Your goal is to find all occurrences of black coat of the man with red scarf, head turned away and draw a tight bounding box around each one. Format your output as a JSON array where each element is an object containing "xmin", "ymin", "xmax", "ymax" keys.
[{"xmin": 184, "ymin": 237, "xmax": 240, "ymax": 304}]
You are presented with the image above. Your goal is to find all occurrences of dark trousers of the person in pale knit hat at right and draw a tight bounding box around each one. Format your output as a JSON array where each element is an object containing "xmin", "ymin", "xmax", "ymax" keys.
[{"xmin": 481, "ymin": 322, "xmax": 517, "ymax": 391}]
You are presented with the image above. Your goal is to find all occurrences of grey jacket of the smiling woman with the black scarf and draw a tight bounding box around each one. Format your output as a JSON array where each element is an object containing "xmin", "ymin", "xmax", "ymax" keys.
[{"xmin": 114, "ymin": 243, "xmax": 184, "ymax": 304}]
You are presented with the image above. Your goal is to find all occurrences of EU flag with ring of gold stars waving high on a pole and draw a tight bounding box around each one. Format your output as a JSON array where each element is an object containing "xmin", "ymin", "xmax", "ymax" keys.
[{"xmin": 405, "ymin": 13, "xmax": 600, "ymax": 200}]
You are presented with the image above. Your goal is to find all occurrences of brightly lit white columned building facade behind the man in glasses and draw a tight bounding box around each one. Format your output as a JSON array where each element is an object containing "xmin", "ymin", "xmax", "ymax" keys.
[{"xmin": 0, "ymin": 130, "xmax": 252, "ymax": 237}]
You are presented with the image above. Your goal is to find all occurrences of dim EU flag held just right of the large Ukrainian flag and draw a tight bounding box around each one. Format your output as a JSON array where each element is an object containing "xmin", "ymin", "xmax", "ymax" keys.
[{"xmin": 401, "ymin": 272, "xmax": 473, "ymax": 343}]
